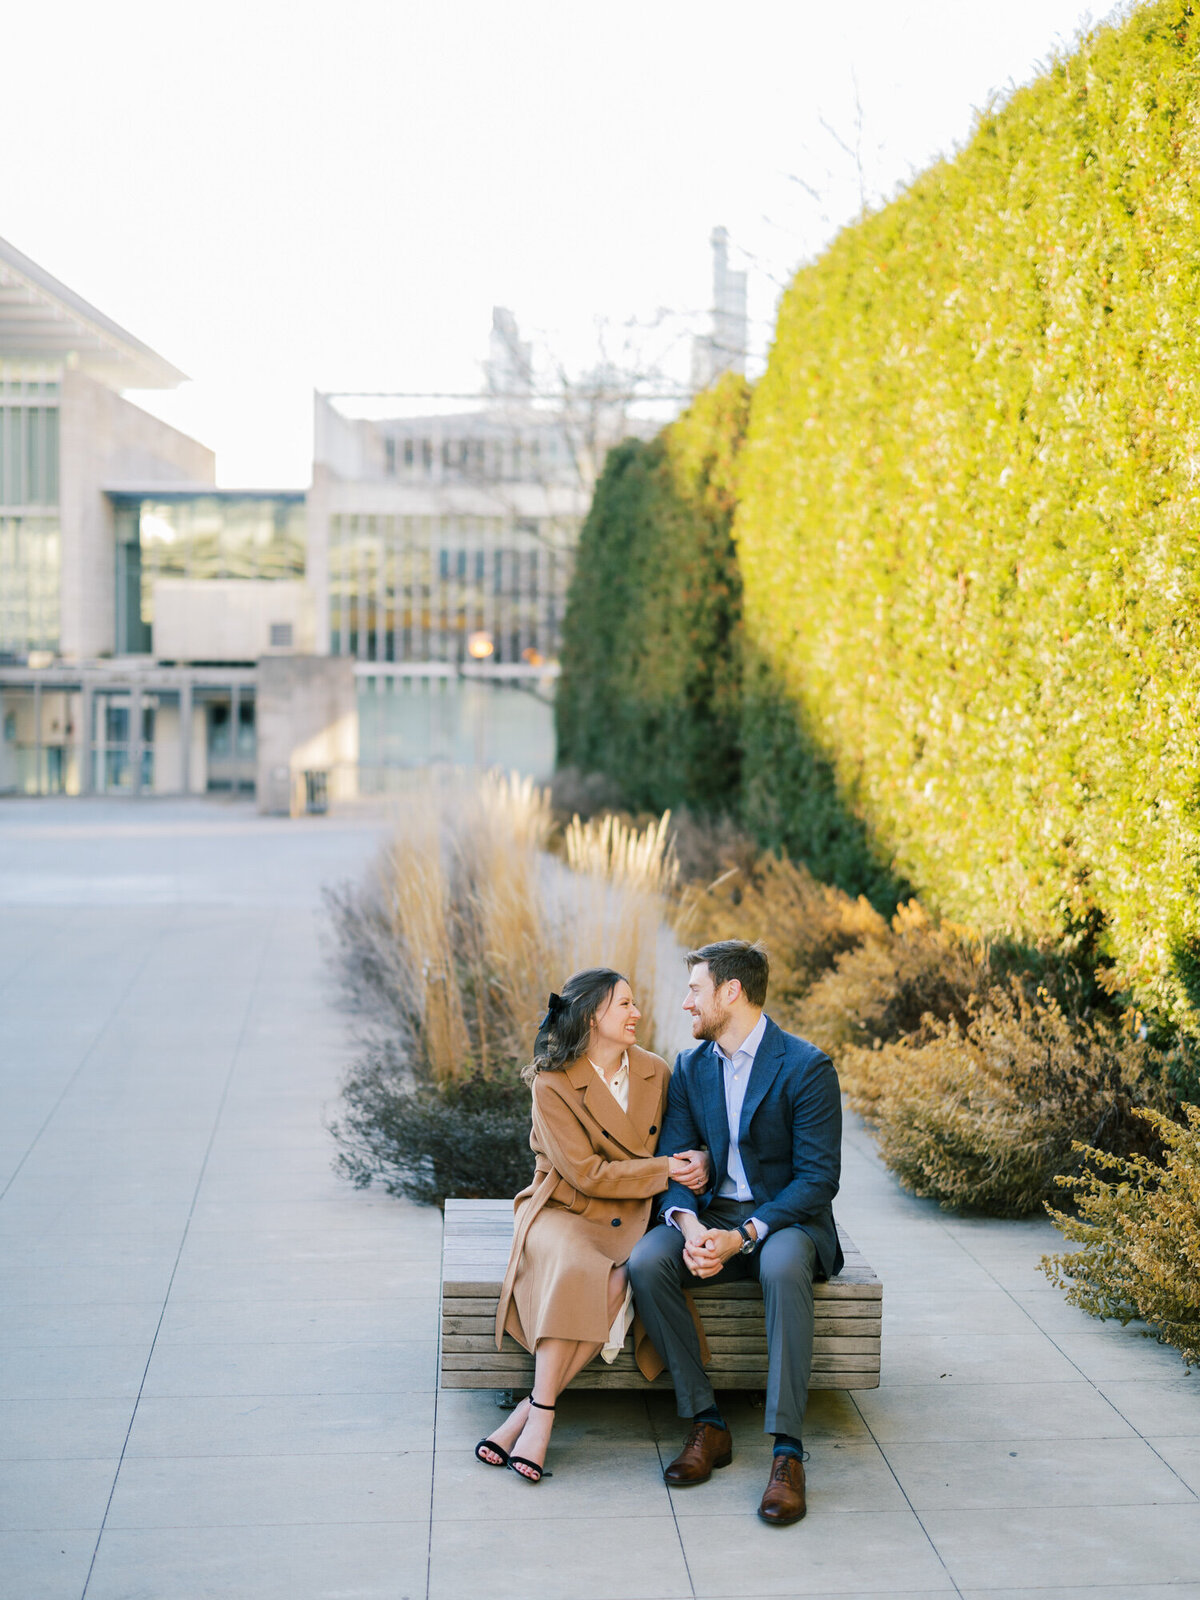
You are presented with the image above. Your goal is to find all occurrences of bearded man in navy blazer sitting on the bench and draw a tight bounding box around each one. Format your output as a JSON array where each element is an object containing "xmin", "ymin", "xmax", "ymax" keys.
[{"xmin": 629, "ymin": 939, "xmax": 842, "ymax": 1526}]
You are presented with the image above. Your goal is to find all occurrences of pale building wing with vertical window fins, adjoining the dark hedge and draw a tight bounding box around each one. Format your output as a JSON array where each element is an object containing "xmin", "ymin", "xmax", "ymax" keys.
[{"xmin": 309, "ymin": 307, "xmax": 624, "ymax": 786}]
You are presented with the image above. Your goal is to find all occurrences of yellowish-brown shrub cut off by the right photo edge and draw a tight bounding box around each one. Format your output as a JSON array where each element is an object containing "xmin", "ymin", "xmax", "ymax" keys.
[{"xmin": 1042, "ymin": 1106, "xmax": 1200, "ymax": 1366}]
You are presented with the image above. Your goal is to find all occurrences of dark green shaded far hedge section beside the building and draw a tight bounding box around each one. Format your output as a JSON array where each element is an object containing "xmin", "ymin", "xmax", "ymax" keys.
[{"xmin": 555, "ymin": 376, "xmax": 749, "ymax": 810}]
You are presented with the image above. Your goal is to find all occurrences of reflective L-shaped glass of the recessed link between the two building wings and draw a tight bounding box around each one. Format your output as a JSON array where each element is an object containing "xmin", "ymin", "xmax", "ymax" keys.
[{"xmin": 112, "ymin": 491, "xmax": 306, "ymax": 654}]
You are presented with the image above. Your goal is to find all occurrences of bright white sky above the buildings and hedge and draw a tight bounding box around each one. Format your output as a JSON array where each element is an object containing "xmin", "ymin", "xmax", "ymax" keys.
[{"xmin": 0, "ymin": 0, "xmax": 1104, "ymax": 486}]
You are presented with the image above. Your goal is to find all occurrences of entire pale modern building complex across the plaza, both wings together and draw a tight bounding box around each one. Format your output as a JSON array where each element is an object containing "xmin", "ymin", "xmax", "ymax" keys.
[{"xmin": 0, "ymin": 235, "xmax": 694, "ymax": 811}]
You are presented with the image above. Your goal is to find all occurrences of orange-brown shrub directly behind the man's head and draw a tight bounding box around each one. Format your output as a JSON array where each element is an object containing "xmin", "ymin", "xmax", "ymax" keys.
[{"xmin": 675, "ymin": 854, "xmax": 888, "ymax": 1029}]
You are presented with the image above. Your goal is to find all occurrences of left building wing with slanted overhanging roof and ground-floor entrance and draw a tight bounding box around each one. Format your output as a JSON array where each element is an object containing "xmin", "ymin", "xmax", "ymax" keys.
[{"xmin": 0, "ymin": 240, "xmax": 342, "ymax": 794}]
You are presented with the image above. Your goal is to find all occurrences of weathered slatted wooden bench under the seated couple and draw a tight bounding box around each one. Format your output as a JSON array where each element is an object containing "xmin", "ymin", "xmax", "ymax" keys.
[{"xmin": 442, "ymin": 1200, "xmax": 883, "ymax": 1389}]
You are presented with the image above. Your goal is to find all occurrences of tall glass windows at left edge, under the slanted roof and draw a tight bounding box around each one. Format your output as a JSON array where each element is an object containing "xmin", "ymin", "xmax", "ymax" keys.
[{"xmin": 0, "ymin": 378, "xmax": 61, "ymax": 656}]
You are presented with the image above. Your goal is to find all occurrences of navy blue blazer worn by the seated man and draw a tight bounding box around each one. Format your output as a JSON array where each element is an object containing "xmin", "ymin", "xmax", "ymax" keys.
[{"xmin": 658, "ymin": 1018, "xmax": 843, "ymax": 1278}]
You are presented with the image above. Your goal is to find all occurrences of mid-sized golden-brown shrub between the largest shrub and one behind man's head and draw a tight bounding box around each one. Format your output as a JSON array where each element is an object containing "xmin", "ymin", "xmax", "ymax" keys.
[{"xmin": 797, "ymin": 901, "xmax": 995, "ymax": 1059}]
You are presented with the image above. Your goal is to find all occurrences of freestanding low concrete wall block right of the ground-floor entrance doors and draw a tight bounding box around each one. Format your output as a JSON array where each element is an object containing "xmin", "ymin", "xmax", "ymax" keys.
[{"xmin": 254, "ymin": 656, "xmax": 358, "ymax": 816}]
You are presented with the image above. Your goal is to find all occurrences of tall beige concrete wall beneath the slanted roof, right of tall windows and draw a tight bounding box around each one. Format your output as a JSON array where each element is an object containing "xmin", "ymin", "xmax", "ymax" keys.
[{"xmin": 59, "ymin": 370, "xmax": 216, "ymax": 661}]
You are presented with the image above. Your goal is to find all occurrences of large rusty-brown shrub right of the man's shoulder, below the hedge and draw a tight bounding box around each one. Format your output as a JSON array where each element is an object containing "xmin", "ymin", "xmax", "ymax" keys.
[{"xmin": 840, "ymin": 981, "xmax": 1173, "ymax": 1216}]
